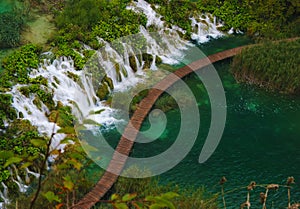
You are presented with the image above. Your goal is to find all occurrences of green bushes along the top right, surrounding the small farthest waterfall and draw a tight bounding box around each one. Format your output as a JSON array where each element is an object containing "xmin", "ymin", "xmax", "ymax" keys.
[{"xmin": 148, "ymin": 0, "xmax": 300, "ymax": 39}]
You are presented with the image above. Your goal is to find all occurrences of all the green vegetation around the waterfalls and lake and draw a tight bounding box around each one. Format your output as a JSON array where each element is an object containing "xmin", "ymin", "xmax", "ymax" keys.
[{"xmin": 0, "ymin": 0, "xmax": 300, "ymax": 209}]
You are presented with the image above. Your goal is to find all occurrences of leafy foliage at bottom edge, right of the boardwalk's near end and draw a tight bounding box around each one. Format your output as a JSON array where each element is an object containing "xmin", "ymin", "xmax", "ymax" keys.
[{"xmin": 99, "ymin": 166, "xmax": 218, "ymax": 209}]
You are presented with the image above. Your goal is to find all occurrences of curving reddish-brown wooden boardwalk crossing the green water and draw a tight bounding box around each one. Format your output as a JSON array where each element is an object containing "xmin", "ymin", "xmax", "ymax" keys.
[{"xmin": 72, "ymin": 46, "xmax": 247, "ymax": 209}]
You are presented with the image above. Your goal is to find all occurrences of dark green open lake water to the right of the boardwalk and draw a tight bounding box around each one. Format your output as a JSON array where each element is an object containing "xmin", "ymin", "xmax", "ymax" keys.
[{"xmin": 99, "ymin": 36, "xmax": 300, "ymax": 208}]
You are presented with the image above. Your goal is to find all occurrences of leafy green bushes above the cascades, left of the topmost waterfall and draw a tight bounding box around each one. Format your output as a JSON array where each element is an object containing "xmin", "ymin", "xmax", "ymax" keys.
[{"xmin": 52, "ymin": 0, "xmax": 146, "ymax": 56}]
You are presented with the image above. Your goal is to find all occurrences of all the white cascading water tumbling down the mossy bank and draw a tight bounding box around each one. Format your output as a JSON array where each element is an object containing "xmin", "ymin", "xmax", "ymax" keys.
[{"xmin": 0, "ymin": 0, "xmax": 232, "ymax": 208}]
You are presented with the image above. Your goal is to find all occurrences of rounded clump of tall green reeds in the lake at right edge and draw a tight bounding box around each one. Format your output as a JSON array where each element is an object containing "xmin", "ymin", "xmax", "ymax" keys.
[{"xmin": 232, "ymin": 40, "xmax": 300, "ymax": 94}]
